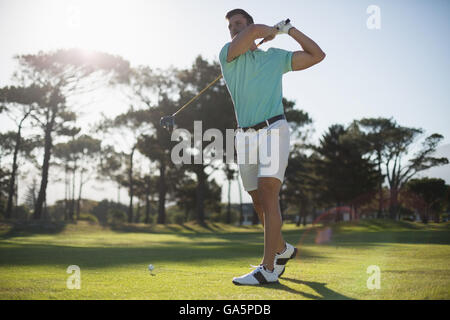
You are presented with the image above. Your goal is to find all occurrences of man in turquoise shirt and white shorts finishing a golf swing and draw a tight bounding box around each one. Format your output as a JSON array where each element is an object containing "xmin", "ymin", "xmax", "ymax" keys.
[{"xmin": 219, "ymin": 9, "xmax": 325, "ymax": 285}]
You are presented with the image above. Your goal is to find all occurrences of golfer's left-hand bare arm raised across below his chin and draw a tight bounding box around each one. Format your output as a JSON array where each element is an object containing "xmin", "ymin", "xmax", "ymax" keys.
[{"xmin": 227, "ymin": 24, "xmax": 278, "ymax": 62}]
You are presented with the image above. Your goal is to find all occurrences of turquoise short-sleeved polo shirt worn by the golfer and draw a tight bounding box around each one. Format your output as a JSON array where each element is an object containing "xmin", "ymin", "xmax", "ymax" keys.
[{"xmin": 219, "ymin": 42, "xmax": 292, "ymax": 127}]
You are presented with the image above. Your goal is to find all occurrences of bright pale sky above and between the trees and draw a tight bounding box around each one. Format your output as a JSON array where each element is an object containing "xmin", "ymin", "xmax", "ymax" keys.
[{"xmin": 0, "ymin": 0, "xmax": 450, "ymax": 203}]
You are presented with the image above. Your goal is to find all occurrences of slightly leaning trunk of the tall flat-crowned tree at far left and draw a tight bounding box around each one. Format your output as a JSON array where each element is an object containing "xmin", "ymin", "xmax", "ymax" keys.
[{"xmin": 33, "ymin": 115, "xmax": 55, "ymax": 220}]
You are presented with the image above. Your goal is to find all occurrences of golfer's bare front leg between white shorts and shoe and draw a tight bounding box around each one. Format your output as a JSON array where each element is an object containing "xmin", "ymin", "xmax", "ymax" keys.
[{"xmin": 252, "ymin": 177, "xmax": 285, "ymax": 270}]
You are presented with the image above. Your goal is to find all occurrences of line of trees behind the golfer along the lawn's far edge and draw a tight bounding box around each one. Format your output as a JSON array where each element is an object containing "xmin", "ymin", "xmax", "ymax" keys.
[{"xmin": 0, "ymin": 49, "xmax": 449, "ymax": 224}]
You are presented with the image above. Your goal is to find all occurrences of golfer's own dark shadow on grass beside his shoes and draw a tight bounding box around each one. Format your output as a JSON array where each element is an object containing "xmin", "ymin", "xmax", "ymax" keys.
[{"xmin": 273, "ymin": 277, "xmax": 355, "ymax": 300}]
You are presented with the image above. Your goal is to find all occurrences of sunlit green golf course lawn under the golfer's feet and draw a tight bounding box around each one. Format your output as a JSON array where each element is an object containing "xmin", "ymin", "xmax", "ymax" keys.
[{"xmin": 0, "ymin": 220, "xmax": 450, "ymax": 299}]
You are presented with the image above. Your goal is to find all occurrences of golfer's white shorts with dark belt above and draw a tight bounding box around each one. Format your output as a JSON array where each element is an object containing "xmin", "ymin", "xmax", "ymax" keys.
[{"xmin": 235, "ymin": 119, "xmax": 290, "ymax": 191}]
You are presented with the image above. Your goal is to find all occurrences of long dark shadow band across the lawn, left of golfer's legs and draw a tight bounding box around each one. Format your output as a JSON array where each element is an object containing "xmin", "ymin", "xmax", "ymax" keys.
[{"xmin": 0, "ymin": 239, "xmax": 320, "ymax": 269}]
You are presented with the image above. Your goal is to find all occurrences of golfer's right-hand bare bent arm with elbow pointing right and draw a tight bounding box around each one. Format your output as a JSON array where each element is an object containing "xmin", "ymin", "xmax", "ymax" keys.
[{"xmin": 288, "ymin": 27, "xmax": 325, "ymax": 71}]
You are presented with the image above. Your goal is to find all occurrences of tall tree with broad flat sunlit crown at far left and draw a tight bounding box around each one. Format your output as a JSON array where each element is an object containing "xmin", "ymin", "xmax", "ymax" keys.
[{"xmin": 15, "ymin": 49, "xmax": 129, "ymax": 219}]
